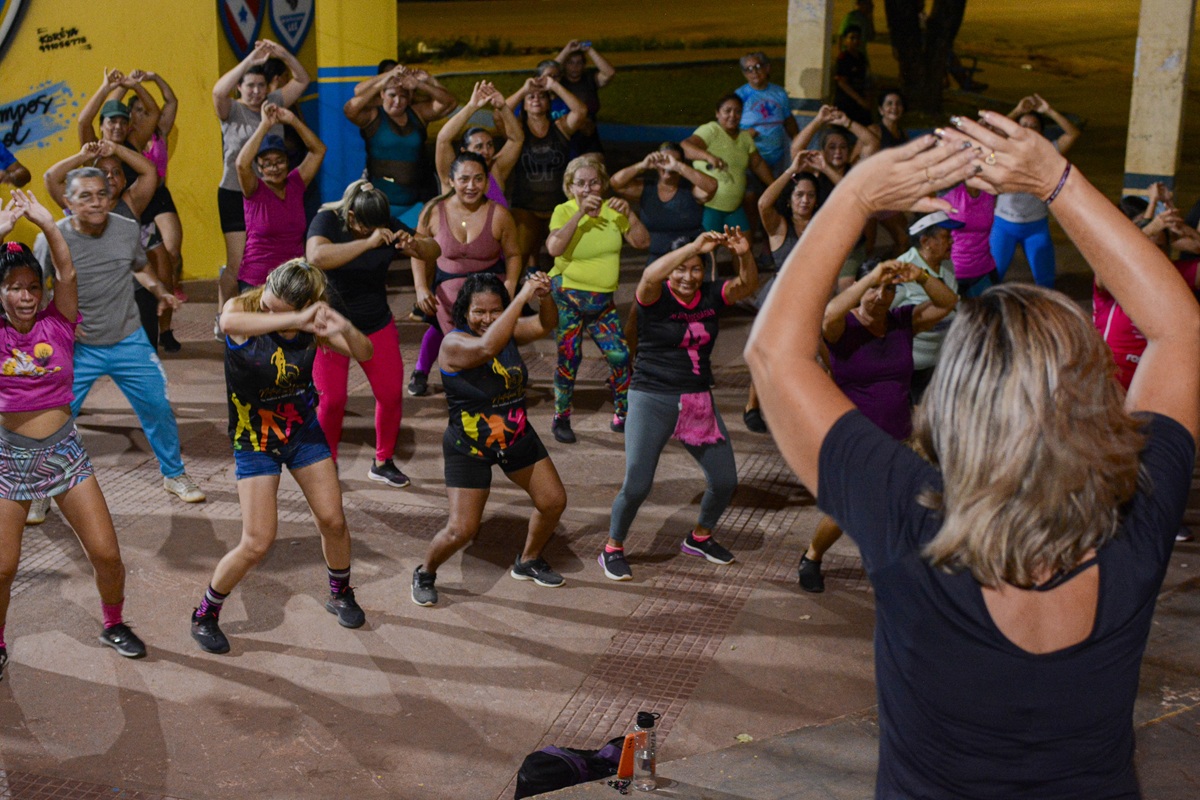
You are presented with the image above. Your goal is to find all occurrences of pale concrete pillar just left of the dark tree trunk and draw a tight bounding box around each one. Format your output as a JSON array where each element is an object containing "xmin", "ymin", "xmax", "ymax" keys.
[{"xmin": 784, "ymin": 0, "xmax": 833, "ymax": 112}]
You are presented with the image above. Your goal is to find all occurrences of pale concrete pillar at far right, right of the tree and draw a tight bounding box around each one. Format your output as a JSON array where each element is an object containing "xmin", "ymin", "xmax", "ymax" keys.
[{"xmin": 1124, "ymin": 0, "xmax": 1196, "ymax": 194}]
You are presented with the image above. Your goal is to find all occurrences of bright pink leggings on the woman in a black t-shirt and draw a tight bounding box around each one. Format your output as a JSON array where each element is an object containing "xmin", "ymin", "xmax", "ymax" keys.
[{"xmin": 312, "ymin": 321, "xmax": 404, "ymax": 462}]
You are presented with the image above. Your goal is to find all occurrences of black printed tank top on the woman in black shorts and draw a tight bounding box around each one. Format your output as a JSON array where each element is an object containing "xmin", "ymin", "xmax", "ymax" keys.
[{"xmin": 442, "ymin": 329, "xmax": 529, "ymax": 457}]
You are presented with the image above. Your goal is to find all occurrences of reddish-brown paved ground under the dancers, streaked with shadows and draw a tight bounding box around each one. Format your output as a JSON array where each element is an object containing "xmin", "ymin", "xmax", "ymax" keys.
[{"xmin": 0, "ymin": 245, "xmax": 1200, "ymax": 800}]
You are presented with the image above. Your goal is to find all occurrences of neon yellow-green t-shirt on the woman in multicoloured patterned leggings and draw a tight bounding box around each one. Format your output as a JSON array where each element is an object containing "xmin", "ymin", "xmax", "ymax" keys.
[{"xmin": 550, "ymin": 199, "xmax": 629, "ymax": 293}]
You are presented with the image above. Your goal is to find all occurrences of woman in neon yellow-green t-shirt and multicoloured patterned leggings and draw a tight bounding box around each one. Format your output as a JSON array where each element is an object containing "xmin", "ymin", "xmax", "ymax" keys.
[{"xmin": 546, "ymin": 154, "xmax": 650, "ymax": 444}]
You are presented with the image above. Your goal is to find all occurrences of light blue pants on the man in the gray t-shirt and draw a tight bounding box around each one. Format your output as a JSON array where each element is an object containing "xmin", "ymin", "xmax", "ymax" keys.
[{"xmin": 71, "ymin": 327, "xmax": 184, "ymax": 477}]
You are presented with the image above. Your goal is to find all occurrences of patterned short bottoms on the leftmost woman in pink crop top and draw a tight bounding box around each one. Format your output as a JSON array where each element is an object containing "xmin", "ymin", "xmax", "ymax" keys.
[{"xmin": 0, "ymin": 420, "xmax": 92, "ymax": 500}]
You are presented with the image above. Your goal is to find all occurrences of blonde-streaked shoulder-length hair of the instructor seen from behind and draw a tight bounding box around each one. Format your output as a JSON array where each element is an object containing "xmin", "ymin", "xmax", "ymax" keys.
[{"xmin": 913, "ymin": 285, "xmax": 1144, "ymax": 588}]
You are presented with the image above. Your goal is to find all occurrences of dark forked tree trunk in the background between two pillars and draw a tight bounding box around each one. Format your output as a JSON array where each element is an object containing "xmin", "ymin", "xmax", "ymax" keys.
[{"xmin": 884, "ymin": 0, "xmax": 967, "ymax": 114}]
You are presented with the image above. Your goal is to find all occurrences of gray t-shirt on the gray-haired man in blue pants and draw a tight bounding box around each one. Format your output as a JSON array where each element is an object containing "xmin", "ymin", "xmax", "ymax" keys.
[{"xmin": 34, "ymin": 213, "xmax": 146, "ymax": 345}]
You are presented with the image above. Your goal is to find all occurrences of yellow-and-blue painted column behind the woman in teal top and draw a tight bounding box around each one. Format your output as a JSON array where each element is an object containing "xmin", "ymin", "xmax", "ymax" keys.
[{"xmin": 314, "ymin": 0, "xmax": 396, "ymax": 201}]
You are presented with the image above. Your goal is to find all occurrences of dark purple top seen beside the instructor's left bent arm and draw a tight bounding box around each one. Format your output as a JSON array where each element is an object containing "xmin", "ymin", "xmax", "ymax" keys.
[{"xmin": 826, "ymin": 306, "xmax": 916, "ymax": 440}]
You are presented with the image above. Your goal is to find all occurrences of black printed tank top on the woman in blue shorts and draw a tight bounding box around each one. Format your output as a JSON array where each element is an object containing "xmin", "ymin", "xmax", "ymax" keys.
[{"xmin": 226, "ymin": 333, "xmax": 317, "ymax": 452}]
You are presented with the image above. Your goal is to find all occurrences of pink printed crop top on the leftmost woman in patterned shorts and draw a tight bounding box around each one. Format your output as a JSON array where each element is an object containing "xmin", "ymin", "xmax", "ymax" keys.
[{"xmin": 0, "ymin": 302, "xmax": 83, "ymax": 414}]
